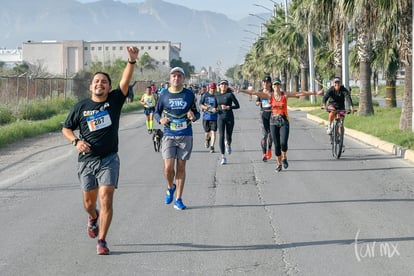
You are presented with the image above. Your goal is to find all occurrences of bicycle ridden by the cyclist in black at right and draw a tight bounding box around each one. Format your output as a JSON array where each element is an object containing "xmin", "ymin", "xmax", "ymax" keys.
[{"xmin": 322, "ymin": 110, "xmax": 355, "ymax": 159}]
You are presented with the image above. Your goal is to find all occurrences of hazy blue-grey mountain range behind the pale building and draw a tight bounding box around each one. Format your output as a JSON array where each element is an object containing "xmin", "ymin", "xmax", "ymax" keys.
[{"xmin": 0, "ymin": 0, "xmax": 270, "ymax": 73}]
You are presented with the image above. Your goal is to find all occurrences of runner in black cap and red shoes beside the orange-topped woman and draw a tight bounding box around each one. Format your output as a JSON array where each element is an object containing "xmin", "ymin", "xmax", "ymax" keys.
[{"xmin": 256, "ymin": 76, "xmax": 273, "ymax": 162}]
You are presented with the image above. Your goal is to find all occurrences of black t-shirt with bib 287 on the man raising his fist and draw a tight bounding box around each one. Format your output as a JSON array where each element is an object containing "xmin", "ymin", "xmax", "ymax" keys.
[{"xmin": 63, "ymin": 88, "xmax": 126, "ymax": 161}]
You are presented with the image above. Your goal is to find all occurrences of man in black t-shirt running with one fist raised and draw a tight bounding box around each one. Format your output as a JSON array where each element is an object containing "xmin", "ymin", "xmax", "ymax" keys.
[{"xmin": 62, "ymin": 47, "xmax": 139, "ymax": 255}]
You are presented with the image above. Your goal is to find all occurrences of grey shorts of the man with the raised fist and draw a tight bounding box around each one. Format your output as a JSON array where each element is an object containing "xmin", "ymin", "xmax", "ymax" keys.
[{"xmin": 78, "ymin": 153, "xmax": 120, "ymax": 192}]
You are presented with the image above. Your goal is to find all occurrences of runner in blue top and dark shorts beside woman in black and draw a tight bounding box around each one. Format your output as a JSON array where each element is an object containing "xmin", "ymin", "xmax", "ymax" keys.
[{"xmin": 199, "ymin": 82, "xmax": 217, "ymax": 153}]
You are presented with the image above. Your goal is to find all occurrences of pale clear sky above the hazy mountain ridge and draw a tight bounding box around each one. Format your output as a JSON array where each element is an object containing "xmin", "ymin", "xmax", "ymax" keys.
[{"xmin": 78, "ymin": 0, "xmax": 285, "ymax": 20}]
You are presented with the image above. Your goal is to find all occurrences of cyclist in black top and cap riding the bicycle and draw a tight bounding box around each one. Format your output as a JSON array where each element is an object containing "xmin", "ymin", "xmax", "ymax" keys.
[{"xmin": 322, "ymin": 77, "xmax": 354, "ymax": 134}]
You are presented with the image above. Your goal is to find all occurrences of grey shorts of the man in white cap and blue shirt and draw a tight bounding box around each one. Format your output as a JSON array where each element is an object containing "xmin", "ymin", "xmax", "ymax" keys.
[{"xmin": 161, "ymin": 136, "xmax": 193, "ymax": 160}]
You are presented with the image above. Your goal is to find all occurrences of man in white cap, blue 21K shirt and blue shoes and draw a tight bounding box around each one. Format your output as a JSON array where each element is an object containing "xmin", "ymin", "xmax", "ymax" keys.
[{"xmin": 154, "ymin": 67, "xmax": 200, "ymax": 210}]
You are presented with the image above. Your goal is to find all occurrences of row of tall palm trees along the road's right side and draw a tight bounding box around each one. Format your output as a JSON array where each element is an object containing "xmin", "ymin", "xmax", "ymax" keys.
[{"xmin": 226, "ymin": 0, "xmax": 412, "ymax": 130}]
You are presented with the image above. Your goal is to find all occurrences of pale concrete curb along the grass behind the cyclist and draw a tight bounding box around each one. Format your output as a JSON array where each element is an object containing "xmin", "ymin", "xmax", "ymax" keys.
[{"xmin": 306, "ymin": 114, "xmax": 414, "ymax": 163}]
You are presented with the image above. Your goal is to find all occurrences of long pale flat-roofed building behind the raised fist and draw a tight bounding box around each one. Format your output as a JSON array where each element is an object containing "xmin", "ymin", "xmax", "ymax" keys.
[{"xmin": 19, "ymin": 40, "xmax": 181, "ymax": 75}]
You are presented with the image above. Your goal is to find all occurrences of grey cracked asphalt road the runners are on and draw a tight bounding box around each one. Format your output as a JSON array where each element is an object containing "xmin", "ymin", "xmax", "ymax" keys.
[{"xmin": 0, "ymin": 94, "xmax": 414, "ymax": 276}]
